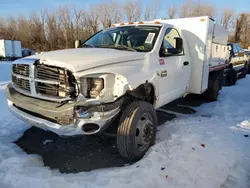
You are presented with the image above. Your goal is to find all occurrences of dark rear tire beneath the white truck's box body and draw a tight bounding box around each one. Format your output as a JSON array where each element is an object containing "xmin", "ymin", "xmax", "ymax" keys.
[{"xmin": 204, "ymin": 77, "xmax": 221, "ymax": 102}]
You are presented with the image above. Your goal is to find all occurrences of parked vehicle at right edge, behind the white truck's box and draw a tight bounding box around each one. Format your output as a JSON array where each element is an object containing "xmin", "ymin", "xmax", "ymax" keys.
[{"xmin": 226, "ymin": 43, "xmax": 248, "ymax": 85}]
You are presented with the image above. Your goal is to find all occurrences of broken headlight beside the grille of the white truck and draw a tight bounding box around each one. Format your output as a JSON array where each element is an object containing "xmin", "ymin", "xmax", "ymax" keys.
[{"xmin": 81, "ymin": 78, "xmax": 104, "ymax": 99}]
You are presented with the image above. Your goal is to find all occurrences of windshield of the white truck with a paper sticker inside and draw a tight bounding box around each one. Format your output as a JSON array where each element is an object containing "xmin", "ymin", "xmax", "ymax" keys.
[{"xmin": 79, "ymin": 25, "xmax": 161, "ymax": 52}]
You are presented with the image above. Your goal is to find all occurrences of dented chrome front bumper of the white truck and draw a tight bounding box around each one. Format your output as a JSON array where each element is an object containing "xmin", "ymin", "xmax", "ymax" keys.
[{"xmin": 6, "ymin": 84, "xmax": 120, "ymax": 136}]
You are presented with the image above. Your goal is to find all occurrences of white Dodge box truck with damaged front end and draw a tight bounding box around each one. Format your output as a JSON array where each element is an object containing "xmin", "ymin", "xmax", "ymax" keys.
[{"xmin": 6, "ymin": 17, "xmax": 228, "ymax": 160}]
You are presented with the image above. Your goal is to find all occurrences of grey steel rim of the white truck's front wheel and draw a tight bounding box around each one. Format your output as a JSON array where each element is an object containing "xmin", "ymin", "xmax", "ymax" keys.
[{"xmin": 135, "ymin": 113, "xmax": 154, "ymax": 151}]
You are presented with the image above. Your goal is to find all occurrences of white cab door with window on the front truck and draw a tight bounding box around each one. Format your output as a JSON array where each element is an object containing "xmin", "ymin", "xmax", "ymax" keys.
[{"xmin": 158, "ymin": 28, "xmax": 191, "ymax": 104}]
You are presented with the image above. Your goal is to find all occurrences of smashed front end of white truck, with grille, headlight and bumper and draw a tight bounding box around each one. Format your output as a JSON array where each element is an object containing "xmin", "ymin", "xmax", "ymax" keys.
[{"xmin": 6, "ymin": 59, "xmax": 131, "ymax": 135}]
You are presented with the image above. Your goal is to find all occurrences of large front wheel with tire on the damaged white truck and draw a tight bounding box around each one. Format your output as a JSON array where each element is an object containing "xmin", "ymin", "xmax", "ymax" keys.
[{"xmin": 117, "ymin": 101, "xmax": 157, "ymax": 161}]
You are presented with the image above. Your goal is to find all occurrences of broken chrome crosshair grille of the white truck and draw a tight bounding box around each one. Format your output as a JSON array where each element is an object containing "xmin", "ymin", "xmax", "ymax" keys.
[{"xmin": 12, "ymin": 62, "xmax": 76, "ymax": 102}]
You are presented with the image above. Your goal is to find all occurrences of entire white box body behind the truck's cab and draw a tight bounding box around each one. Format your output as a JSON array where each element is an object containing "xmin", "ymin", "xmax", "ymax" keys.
[{"xmin": 165, "ymin": 16, "xmax": 228, "ymax": 94}]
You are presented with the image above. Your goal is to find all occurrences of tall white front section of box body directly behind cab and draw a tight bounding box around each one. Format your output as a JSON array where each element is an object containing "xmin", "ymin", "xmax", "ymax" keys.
[{"xmin": 167, "ymin": 17, "xmax": 212, "ymax": 94}]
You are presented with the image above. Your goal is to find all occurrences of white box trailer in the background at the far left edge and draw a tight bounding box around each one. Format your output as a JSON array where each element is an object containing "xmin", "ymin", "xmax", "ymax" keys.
[{"xmin": 0, "ymin": 39, "xmax": 22, "ymax": 60}]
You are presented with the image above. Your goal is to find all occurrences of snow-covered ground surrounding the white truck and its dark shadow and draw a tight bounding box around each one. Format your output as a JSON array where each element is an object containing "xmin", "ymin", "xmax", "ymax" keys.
[{"xmin": 0, "ymin": 62, "xmax": 250, "ymax": 188}]
